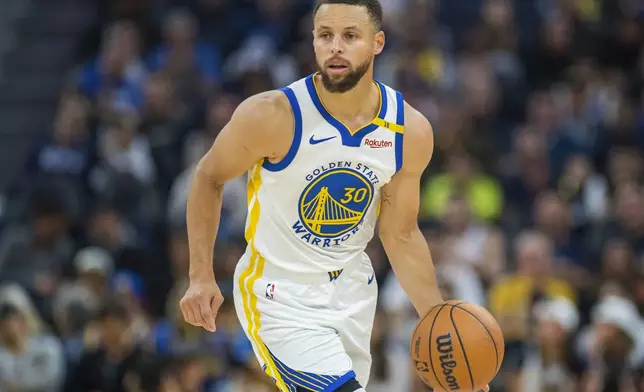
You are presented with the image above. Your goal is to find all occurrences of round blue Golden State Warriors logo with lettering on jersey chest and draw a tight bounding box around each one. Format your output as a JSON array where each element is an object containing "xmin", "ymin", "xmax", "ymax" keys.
[{"xmin": 293, "ymin": 162, "xmax": 378, "ymax": 247}]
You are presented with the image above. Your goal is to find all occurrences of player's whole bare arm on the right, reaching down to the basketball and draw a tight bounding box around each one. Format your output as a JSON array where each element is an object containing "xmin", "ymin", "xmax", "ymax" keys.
[{"xmin": 379, "ymin": 107, "xmax": 442, "ymax": 316}]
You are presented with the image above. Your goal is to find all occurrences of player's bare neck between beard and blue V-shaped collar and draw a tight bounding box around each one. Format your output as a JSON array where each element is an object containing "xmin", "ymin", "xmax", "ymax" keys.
[{"xmin": 316, "ymin": 73, "xmax": 380, "ymax": 118}]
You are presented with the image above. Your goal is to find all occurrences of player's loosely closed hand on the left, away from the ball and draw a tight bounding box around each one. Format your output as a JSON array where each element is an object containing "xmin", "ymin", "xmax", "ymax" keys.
[{"xmin": 179, "ymin": 280, "xmax": 224, "ymax": 332}]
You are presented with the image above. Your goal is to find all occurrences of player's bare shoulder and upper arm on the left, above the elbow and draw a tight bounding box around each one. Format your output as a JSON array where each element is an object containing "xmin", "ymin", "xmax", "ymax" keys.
[{"xmin": 197, "ymin": 91, "xmax": 294, "ymax": 184}]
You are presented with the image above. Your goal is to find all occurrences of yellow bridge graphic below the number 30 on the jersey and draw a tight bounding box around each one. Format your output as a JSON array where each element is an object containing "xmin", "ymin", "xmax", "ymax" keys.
[{"xmin": 302, "ymin": 187, "xmax": 363, "ymax": 234}]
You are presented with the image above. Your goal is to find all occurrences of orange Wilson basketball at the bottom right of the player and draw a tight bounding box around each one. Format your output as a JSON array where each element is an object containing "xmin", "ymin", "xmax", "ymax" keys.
[{"xmin": 411, "ymin": 301, "xmax": 504, "ymax": 392}]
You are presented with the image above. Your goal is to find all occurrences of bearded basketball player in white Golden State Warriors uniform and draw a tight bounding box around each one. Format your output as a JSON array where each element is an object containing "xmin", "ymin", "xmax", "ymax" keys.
[{"xmin": 181, "ymin": 0, "xmax": 488, "ymax": 392}]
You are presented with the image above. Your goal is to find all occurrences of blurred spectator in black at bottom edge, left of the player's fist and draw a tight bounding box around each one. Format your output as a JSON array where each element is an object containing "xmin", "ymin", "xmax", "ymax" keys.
[{"xmin": 65, "ymin": 301, "xmax": 143, "ymax": 392}]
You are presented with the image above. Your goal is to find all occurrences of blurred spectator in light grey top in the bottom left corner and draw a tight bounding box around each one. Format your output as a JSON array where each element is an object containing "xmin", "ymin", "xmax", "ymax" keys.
[{"xmin": 0, "ymin": 303, "xmax": 65, "ymax": 392}]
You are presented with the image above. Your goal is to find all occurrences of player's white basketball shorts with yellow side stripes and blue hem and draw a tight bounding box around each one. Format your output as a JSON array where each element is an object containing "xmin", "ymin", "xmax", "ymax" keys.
[{"xmin": 234, "ymin": 250, "xmax": 378, "ymax": 392}]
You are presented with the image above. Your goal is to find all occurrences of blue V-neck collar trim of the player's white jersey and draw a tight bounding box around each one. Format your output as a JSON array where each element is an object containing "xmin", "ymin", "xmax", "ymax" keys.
[{"xmin": 306, "ymin": 74, "xmax": 387, "ymax": 147}]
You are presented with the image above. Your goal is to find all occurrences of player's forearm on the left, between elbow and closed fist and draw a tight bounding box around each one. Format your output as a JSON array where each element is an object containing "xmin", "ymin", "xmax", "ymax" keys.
[{"xmin": 186, "ymin": 169, "xmax": 224, "ymax": 280}]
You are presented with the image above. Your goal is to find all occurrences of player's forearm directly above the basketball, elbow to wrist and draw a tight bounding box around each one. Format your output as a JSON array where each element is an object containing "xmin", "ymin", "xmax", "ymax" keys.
[{"xmin": 381, "ymin": 229, "xmax": 443, "ymax": 315}]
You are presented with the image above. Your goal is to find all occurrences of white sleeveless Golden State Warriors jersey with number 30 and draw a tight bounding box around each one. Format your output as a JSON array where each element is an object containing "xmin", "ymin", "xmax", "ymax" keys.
[{"xmin": 246, "ymin": 75, "xmax": 404, "ymax": 275}]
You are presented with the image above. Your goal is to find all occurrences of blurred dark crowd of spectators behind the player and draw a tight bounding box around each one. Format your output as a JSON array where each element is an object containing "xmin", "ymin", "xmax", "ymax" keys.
[{"xmin": 0, "ymin": 0, "xmax": 644, "ymax": 392}]
